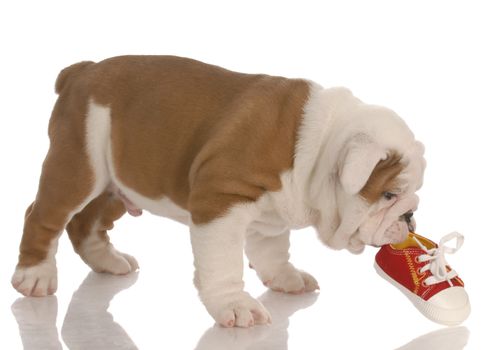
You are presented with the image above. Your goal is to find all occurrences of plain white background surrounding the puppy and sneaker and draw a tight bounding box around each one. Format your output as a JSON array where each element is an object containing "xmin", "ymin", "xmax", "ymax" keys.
[{"xmin": 0, "ymin": 0, "xmax": 500, "ymax": 350}]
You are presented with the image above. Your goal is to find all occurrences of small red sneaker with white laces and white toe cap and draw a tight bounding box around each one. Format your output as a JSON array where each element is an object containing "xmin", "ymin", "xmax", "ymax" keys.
[{"xmin": 375, "ymin": 232, "xmax": 470, "ymax": 326}]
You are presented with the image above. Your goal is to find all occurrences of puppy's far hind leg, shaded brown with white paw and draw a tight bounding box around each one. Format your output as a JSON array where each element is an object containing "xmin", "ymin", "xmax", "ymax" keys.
[{"xmin": 66, "ymin": 192, "xmax": 139, "ymax": 275}]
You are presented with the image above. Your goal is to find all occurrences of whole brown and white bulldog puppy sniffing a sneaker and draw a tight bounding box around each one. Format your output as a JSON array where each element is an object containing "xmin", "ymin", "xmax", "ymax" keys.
[{"xmin": 12, "ymin": 56, "xmax": 425, "ymax": 327}]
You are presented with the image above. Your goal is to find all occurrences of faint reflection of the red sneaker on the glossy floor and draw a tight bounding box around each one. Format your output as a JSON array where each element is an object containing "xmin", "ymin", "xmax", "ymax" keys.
[{"xmin": 396, "ymin": 327, "xmax": 469, "ymax": 350}]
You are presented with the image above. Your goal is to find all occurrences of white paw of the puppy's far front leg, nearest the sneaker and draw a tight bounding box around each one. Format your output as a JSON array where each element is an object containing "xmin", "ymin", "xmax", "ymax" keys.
[{"xmin": 264, "ymin": 264, "xmax": 319, "ymax": 294}]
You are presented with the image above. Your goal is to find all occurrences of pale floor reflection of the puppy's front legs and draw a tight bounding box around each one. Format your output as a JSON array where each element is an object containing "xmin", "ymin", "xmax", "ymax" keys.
[{"xmin": 195, "ymin": 291, "xmax": 319, "ymax": 350}]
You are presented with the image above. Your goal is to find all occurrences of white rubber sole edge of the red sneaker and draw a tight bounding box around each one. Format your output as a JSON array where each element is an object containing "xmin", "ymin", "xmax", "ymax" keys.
[{"xmin": 373, "ymin": 262, "xmax": 470, "ymax": 326}]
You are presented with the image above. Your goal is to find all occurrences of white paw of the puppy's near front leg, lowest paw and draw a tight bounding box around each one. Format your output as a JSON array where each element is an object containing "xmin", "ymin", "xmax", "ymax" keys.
[{"xmin": 205, "ymin": 292, "xmax": 271, "ymax": 328}]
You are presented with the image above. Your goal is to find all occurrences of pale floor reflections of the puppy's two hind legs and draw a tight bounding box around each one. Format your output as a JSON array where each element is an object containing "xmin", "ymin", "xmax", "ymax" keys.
[{"xmin": 12, "ymin": 272, "xmax": 138, "ymax": 350}]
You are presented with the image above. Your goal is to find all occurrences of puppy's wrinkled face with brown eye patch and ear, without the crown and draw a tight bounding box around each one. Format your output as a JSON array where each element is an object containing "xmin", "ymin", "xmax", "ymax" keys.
[{"xmin": 336, "ymin": 133, "xmax": 425, "ymax": 252}]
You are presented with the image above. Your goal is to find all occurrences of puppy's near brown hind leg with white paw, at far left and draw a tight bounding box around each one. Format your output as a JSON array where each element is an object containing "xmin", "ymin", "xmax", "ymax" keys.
[{"xmin": 12, "ymin": 110, "xmax": 102, "ymax": 296}]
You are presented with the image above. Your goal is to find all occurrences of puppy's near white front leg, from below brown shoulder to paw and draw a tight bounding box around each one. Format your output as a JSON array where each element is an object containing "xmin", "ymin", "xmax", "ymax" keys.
[{"xmin": 190, "ymin": 211, "xmax": 271, "ymax": 327}]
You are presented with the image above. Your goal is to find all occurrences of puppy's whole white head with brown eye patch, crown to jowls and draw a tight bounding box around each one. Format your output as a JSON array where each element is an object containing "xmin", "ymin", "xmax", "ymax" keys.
[{"xmin": 320, "ymin": 100, "xmax": 425, "ymax": 252}]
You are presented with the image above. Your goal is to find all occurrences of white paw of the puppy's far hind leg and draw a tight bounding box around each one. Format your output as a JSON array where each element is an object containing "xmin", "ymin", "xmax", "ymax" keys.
[{"xmin": 82, "ymin": 245, "xmax": 139, "ymax": 275}]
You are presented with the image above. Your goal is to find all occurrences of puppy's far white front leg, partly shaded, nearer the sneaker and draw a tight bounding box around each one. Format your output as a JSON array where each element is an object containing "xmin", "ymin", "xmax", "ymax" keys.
[{"xmin": 245, "ymin": 230, "xmax": 319, "ymax": 294}]
